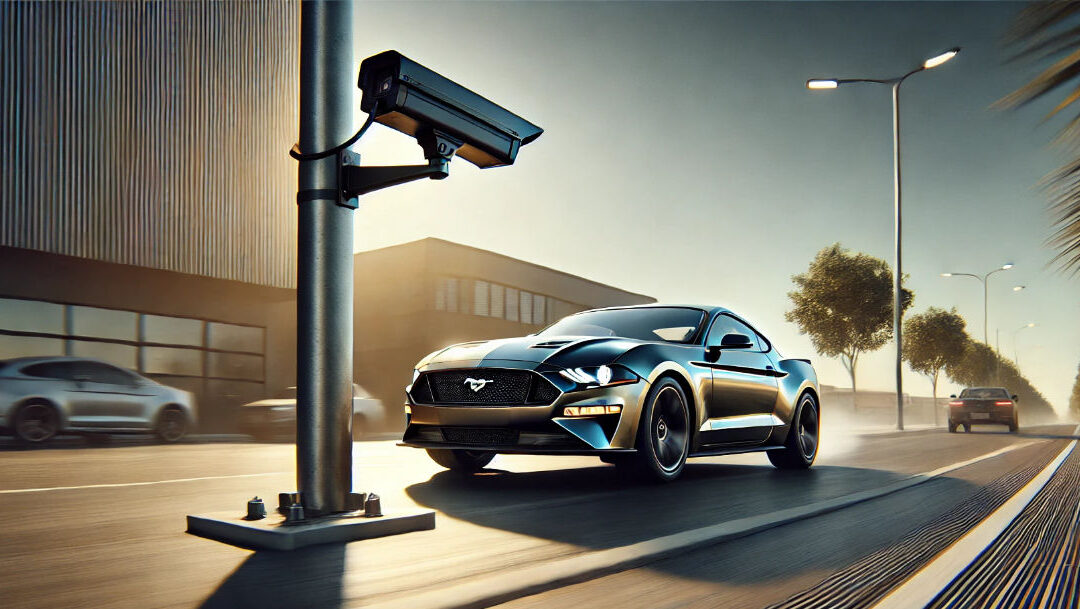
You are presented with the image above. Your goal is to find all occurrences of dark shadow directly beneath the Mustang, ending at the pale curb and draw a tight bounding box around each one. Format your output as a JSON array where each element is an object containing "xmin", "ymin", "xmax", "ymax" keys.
[{"xmin": 406, "ymin": 462, "xmax": 937, "ymax": 550}]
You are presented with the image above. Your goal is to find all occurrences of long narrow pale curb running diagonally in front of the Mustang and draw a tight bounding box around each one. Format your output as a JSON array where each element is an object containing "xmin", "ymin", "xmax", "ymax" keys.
[{"xmin": 365, "ymin": 442, "xmax": 1035, "ymax": 609}]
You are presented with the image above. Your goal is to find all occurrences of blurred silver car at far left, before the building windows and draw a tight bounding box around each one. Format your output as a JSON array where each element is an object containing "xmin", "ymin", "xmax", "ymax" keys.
[{"xmin": 0, "ymin": 357, "xmax": 195, "ymax": 444}]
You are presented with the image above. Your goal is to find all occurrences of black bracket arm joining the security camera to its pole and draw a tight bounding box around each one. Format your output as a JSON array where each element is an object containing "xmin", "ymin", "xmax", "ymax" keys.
[{"xmin": 338, "ymin": 130, "xmax": 462, "ymax": 209}]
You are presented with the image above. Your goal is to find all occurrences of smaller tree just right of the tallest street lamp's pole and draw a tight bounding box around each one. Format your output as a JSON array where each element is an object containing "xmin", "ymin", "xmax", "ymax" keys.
[{"xmin": 904, "ymin": 307, "xmax": 970, "ymax": 425}]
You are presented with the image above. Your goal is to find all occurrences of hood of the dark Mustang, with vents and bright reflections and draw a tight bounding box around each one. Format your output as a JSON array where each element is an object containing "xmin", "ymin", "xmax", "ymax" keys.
[{"xmin": 417, "ymin": 336, "xmax": 644, "ymax": 369}]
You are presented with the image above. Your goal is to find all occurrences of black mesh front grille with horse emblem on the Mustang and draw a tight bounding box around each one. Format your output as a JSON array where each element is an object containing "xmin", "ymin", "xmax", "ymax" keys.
[{"xmin": 413, "ymin": 368, "xmax": 559, "ymax": 406}]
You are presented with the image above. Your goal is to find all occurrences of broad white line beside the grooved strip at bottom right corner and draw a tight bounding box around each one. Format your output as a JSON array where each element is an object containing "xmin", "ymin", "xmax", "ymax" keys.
[{"xmin": 873, "ymin": 427, "xmax": 1080, "ymax": 609}]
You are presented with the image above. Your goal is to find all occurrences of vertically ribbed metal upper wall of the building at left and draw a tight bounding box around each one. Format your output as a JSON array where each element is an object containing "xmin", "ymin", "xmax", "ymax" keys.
[{"xmin": 0, "ymin": 1, "xmax": 299, "ymax": 286}]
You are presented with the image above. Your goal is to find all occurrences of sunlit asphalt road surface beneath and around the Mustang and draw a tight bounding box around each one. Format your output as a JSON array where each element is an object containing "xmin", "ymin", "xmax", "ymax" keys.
[{"xmin": 0, "ymin": 425, "xmax": 1074, "ymax": 608}]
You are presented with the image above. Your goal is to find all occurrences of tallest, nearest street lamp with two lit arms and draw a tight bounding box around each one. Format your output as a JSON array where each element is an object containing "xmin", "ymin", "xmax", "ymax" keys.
[{"xmin": 807, "ymin": 46, "xmax": 960, "ymax": 431}]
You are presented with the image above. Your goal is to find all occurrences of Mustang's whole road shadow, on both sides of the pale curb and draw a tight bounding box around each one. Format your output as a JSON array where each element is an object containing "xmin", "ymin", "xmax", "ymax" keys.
[{"xmin": 406, "ymin": 463, "xmax": 978, "ymax": 591}]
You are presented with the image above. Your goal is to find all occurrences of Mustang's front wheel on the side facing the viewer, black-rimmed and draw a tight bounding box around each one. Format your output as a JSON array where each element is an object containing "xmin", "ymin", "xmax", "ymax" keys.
[{"xmin": 615, "ymin": 377, "xmax": 690, "ymax": 483}]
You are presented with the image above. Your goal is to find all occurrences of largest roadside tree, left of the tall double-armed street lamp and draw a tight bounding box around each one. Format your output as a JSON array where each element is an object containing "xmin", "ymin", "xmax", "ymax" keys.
[{"xmin": 784, "ymin": 243, "xmax": 915, "ymax": 400}]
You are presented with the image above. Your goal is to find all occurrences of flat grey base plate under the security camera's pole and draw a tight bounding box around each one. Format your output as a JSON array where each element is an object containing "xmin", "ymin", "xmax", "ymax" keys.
[{"xmin": 188, "ymin": 510, "xmax": 435, "ymax": 550}]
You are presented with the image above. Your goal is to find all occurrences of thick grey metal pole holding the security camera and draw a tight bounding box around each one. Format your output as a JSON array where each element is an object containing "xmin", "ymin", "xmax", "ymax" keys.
[{"xmin": 296, "ymin": 0, "xmax": 356, "ymax": 516}]
